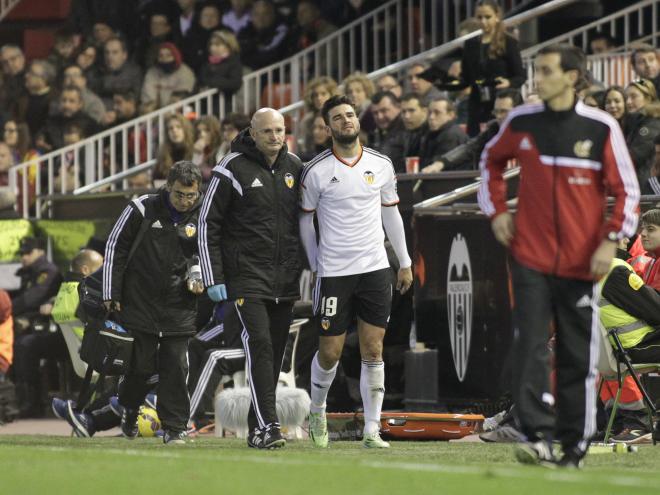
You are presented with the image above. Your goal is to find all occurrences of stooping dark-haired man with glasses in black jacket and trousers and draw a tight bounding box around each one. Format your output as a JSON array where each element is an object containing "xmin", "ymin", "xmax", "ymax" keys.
[{"xmin": 103, "ymin": 161, "xmax": 204, "ymax": 443}]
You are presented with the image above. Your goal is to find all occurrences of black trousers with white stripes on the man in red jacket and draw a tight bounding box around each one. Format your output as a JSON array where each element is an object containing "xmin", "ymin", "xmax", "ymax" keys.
[{"xmin": 512, "ymin": 261, "xmax": 600, "ymax": 454}]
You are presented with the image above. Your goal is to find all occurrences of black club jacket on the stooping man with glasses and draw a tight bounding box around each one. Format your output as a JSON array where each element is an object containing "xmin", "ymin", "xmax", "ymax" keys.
[{"xmin": 103, "ymin": 190, "xmax": 202, "ymax": 336}]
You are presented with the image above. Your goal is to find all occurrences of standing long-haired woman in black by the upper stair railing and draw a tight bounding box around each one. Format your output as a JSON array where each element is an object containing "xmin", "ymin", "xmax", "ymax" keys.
[{"xmin": 461, "ymin": 0, "xmax": 525, "ymax": 136}]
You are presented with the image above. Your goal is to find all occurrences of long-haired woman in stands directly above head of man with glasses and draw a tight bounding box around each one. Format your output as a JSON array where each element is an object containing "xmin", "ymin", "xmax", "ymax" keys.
[{"xmin": 154, "ymin": 113, "xmax": 193, "ymax": 181}]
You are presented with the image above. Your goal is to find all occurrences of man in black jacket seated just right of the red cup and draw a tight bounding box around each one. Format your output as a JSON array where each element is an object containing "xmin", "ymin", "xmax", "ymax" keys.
[{"xmin": 419, "ymin": 98, "xmax": 468, "ymax": 172}]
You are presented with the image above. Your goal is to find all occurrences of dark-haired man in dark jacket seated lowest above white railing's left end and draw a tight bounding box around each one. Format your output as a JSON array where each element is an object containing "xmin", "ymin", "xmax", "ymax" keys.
[{"xmin": 43, "ymin": 86, "xmax": 99, "ymax": 150}]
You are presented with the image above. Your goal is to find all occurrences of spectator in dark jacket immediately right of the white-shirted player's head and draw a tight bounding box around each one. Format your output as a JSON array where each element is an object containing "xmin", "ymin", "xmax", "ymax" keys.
[{"xmin": 369, "ymin": 92, "xmax": 406, "ymax": 173}]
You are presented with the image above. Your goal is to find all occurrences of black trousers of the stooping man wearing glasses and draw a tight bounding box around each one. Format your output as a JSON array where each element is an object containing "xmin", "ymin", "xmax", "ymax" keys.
[{"xmin": 119, "ymin": 331, "xmax": 190, "ymax": 432}]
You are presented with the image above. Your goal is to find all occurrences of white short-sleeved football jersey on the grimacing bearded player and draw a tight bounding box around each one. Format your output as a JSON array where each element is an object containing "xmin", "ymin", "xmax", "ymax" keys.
[{"xmin": 301, "ymin": 148, "xmax": 399, "ymax": 277}]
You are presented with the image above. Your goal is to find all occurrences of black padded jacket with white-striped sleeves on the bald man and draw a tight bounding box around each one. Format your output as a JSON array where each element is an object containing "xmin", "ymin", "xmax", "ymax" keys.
[{"xmin": 199, "ymin": 129, "xmax": 302, "ymax": 300}]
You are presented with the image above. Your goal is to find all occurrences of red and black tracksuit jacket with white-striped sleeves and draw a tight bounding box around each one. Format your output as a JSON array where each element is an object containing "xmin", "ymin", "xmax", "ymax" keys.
[{"xmin": 478, "ymin": 101, "xmax": 639, "ymax": 280}]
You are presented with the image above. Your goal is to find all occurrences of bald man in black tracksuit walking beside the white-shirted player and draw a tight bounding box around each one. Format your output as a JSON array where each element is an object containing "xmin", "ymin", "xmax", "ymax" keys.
[{"xmin": 199, "ymin": 108, "xmax": 302, "ymax": 448}]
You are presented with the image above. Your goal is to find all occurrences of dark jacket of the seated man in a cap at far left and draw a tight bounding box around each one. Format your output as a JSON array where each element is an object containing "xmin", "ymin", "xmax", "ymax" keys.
[{"xmin": 11, "ymin": 256, "xmax": 62, "ymax": 317}]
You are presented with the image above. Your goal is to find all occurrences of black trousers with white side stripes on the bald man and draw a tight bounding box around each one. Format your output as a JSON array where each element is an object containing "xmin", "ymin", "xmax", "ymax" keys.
[{"xmin": 225, "ymin": 299, "xmax": 293, "ymax": 430}]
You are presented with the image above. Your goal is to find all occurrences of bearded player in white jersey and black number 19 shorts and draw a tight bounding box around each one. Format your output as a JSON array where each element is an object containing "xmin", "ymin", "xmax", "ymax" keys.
[{"xmin": 300, "ymin": 96, "xmax": 413, "ymax": 448}]
